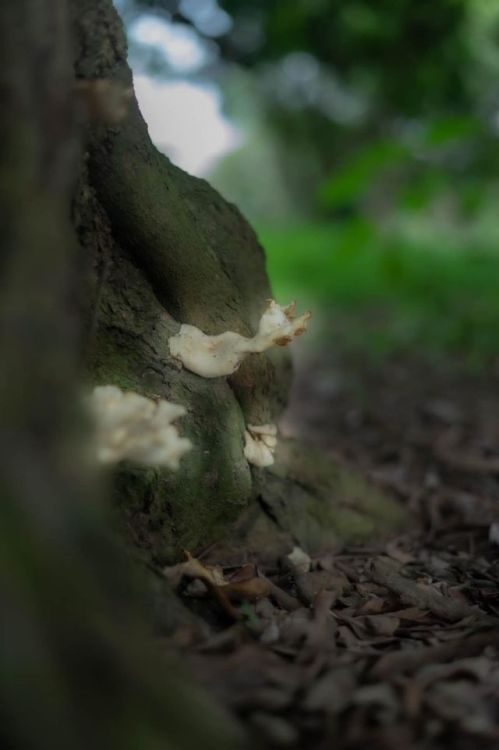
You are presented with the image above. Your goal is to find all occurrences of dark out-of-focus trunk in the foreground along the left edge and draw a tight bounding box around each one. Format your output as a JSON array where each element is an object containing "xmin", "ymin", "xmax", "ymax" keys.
[{"xmin": 0, "ymin": 0, "xmax": 242, "ymax": 750}]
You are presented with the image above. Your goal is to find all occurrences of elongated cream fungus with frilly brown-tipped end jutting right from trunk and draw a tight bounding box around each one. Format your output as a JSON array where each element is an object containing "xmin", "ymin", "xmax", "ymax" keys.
[{"xmin": 169, "ymin": 300, "xmax": 311, "ymax": 378}]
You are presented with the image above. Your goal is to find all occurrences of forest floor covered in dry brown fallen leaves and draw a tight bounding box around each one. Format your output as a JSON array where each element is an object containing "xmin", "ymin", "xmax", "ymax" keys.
[{"xmin": 161, "ymin": 342, "xmax": 499, "ymax": 750}]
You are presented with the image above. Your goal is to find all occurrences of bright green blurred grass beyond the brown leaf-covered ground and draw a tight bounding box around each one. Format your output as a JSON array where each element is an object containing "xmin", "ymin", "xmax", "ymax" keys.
[{"xmin": 259, "ymin": 220, "xmax": 499, "ymax": 366}]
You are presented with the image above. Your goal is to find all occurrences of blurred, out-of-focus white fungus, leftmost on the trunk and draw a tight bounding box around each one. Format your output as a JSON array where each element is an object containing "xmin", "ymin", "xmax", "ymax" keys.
[{"xmin": 91, "ymin": 385, "xmax": 192, "ymax": 469}]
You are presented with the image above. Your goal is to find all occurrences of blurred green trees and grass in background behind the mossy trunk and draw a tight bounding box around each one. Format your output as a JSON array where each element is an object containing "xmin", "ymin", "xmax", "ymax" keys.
[{"xmin": 116, "ymin": 0, "xmax": 499, "ymax": 362}]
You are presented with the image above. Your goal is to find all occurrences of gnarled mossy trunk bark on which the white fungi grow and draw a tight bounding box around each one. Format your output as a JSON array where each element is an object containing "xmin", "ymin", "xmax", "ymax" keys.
[{"xmin": 73, "ymin": 0, "xmax": 406, "ymax": 562}]
